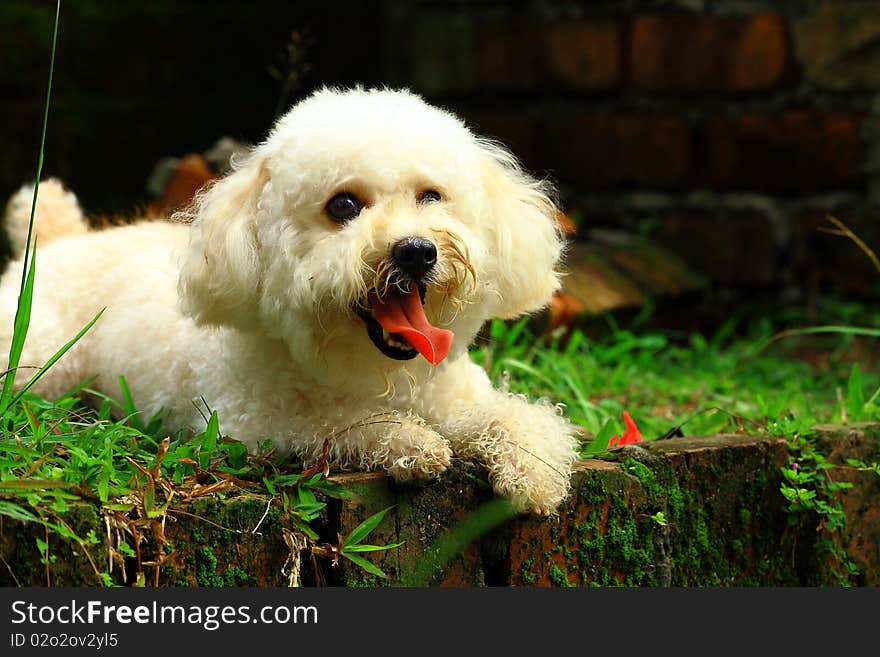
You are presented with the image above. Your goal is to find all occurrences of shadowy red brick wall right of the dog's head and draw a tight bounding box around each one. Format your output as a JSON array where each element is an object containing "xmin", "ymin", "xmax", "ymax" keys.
[{"xmin": 392, "ymin": 0, "xmax": 880, "ymax": 298}]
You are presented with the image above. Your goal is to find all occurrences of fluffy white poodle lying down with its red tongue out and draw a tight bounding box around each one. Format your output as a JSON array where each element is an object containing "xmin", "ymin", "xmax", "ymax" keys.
[{"xmin": 0, "ymin": 89, "xmax": 576, "ymax": 514}]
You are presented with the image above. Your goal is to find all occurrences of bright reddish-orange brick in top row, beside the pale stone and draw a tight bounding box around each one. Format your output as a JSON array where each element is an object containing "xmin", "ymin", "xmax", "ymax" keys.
[{"xmin": 630, "ymin": 13, "xmax": 790, "ymax": 92}]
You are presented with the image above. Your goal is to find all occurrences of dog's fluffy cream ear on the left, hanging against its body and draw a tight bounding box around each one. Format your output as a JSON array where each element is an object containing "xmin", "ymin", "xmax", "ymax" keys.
[{"xmin": 178, "ymin": 156, "xmax": 268, "ymax": 328}]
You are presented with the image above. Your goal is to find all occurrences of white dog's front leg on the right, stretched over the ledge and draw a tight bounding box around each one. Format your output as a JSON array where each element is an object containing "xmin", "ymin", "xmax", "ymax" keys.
[{"xmin": 421, "ymin": 355, "xmax": 577, "ymax": 515}]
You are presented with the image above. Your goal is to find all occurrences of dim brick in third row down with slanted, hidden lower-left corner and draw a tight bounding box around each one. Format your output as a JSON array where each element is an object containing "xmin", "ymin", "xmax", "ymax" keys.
[{"xmin": 655, "ymin": 211, "xmax": 777, "ymax": 287}]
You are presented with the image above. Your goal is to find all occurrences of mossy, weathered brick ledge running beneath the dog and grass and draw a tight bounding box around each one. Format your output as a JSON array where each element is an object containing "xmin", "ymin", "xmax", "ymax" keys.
[{"xmin": 0, "ymin": 425, "xmax": 880, "ymax": 587}]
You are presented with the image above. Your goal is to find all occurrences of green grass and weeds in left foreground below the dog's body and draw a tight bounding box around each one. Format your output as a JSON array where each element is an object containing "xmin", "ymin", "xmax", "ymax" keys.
[{"xmin": 0, "ymin": 384, "xmax": 396, "ymax": 584}]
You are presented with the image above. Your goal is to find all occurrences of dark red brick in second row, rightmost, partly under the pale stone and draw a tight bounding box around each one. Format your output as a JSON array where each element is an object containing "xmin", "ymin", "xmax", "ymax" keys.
[{"xmin": 704, "ymin": 110, "xmax": 864, "ymax": 194}]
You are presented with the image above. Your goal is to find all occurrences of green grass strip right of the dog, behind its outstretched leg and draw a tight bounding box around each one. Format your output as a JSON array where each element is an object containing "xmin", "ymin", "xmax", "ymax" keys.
[{"xmin": 474, "ymin": 304, "xmax": 880, "ymax": 451}]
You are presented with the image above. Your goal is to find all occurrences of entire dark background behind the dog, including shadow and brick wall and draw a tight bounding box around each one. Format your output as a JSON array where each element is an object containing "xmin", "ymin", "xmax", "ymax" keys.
[{"xmin": 0, "ymin": 0, "xmax": 880, "ymax": 328}]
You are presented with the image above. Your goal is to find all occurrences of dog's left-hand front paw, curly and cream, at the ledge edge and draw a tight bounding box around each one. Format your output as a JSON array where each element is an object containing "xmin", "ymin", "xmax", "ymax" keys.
[{"xmin": 382, "ymin": 421, "xmax": 452, "ymax": 481}]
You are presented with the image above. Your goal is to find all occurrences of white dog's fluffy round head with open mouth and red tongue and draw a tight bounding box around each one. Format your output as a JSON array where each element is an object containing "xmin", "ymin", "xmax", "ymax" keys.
[{"xmin": 180, "ymin": 89, "xmax": 562, "ymax": 382}]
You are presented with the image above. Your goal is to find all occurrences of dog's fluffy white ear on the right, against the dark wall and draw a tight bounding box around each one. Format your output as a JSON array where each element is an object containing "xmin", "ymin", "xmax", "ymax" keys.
[{"xmin": 481, "ymin": 141, "xmax": 563, "ymax": 319}]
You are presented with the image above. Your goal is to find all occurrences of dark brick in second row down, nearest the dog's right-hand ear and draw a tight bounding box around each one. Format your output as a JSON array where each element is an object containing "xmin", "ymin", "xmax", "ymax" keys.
[{"xmin": 541, "ymin": 112, "xmax": 692, "ymax": 189}]
